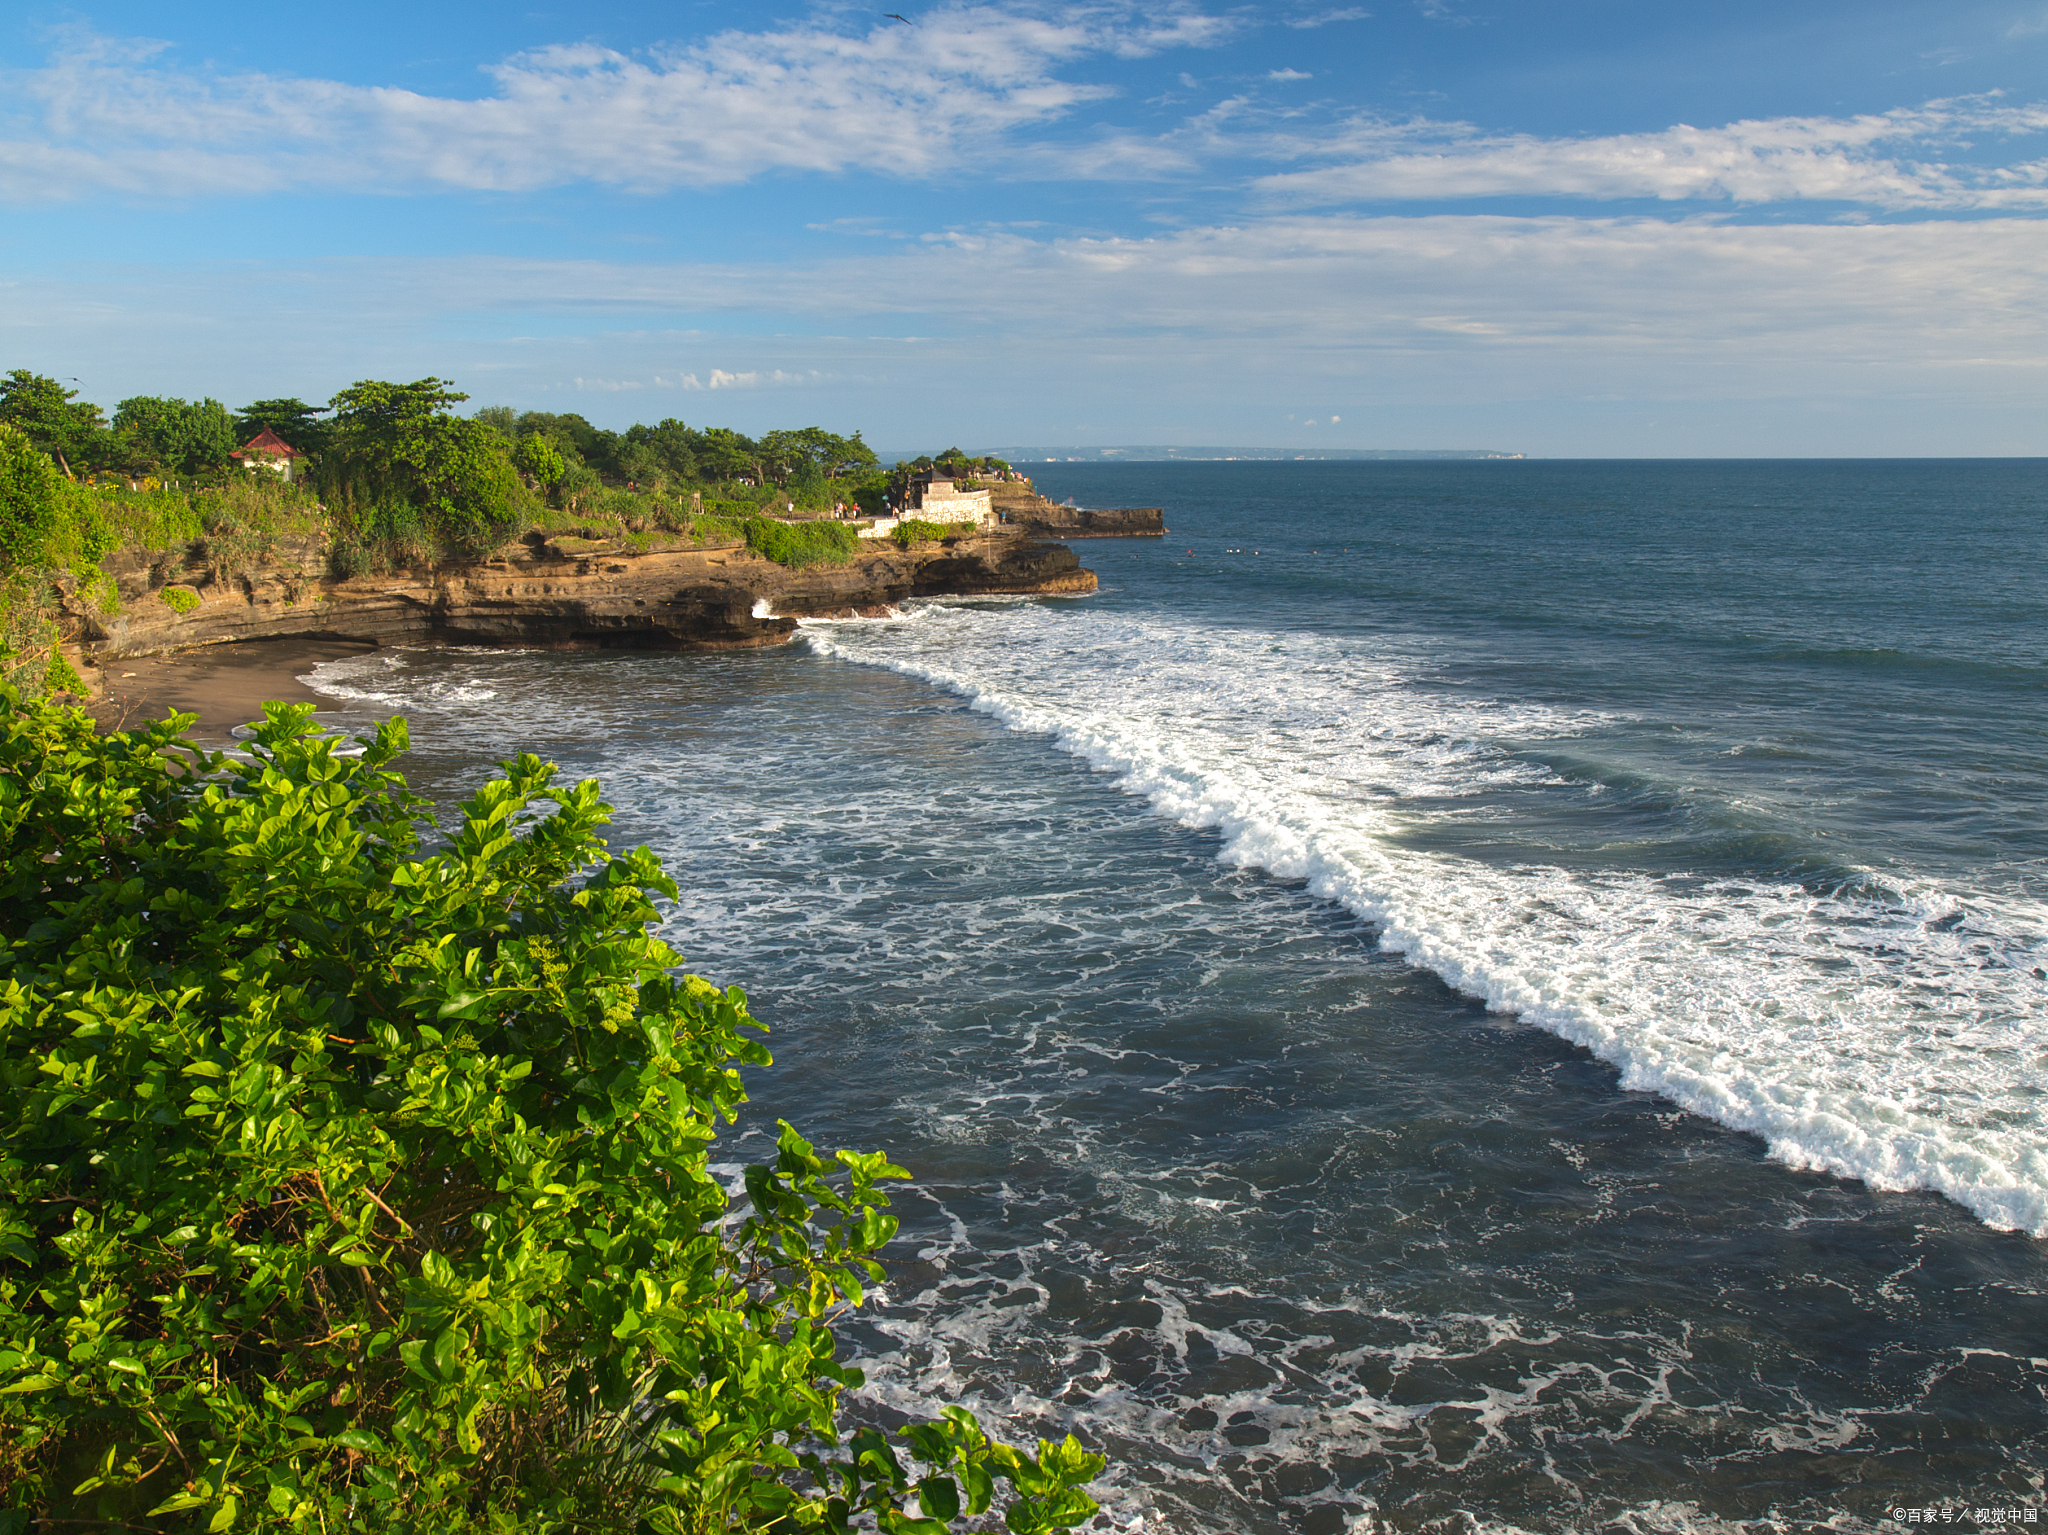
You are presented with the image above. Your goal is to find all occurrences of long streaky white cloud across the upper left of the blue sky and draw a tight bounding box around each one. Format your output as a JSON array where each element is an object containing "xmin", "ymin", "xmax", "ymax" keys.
[{"xmin": 0, "ymin": 0, "xmax": 1235, "ymax": 201}]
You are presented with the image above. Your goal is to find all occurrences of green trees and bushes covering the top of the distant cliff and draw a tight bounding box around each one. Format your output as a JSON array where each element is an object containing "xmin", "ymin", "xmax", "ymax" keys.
[{"xmin": 0, "ymin": 368, "xmax": 942, "ymax": 690}]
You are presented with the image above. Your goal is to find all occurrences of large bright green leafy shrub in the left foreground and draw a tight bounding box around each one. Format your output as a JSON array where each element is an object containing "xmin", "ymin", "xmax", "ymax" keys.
[{"xmin": 0, "ymin": 692, "xmax": 1100, "ymax": 1535}]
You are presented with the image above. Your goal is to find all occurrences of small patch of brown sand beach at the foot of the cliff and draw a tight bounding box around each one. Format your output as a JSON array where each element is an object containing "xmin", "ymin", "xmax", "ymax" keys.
[{"xmin": 86, "ymin": 639, "xmax": 377, "ymax": 745}]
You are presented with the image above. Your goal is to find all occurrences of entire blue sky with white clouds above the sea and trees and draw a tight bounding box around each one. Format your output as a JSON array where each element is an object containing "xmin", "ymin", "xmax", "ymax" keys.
[{"xmin": 0, "ymin": 0, "xmax": 2048, "ymax": 456}]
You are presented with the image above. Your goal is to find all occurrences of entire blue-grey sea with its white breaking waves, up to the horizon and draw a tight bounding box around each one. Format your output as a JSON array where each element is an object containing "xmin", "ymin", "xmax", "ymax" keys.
[{"xmin": 309, "ymin": 461, "xmax": 2048, "ymax": 1535}]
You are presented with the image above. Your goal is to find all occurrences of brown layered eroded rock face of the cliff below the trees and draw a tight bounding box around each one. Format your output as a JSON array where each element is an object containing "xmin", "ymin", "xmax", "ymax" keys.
[{"xmin": 68, "ymin": 528, "xmax": 1096, "ymax": 663}]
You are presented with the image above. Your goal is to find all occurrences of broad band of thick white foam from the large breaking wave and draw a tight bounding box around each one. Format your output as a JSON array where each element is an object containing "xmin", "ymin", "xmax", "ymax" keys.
[{"xmin": 803, "ymin": 604, "xmax": 2048, "ymax": 1236}]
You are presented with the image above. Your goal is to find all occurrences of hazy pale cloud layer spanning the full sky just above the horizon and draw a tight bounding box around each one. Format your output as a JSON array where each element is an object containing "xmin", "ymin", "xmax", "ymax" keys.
[{"xmin": 0, "ymin": 215, "xmax": 2048, "ymax": 454}]
